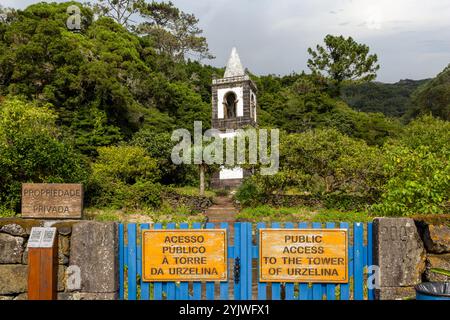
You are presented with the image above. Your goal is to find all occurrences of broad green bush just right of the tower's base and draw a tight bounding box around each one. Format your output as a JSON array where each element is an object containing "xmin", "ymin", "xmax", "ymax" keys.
[{"xmin": 236, "ymin": 129, "xmax": 386, "ymax": 210}]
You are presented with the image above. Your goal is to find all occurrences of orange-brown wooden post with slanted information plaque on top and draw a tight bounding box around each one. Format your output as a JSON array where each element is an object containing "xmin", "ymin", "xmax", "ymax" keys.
[{"xmin": 28, "ymin": 228, "xmax": 58, "ymax": 300}]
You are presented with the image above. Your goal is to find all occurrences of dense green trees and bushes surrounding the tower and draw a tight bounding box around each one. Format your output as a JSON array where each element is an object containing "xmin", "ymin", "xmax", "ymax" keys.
[{"xmin": 0, "ymin": 1, "xmax": 450, "ymax": 220}]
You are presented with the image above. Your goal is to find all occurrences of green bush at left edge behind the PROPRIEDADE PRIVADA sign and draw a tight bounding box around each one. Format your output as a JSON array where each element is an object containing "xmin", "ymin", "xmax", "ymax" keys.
[{"xmin": 0, "ymin": 99, "xmax": 88, "ymax": 215}]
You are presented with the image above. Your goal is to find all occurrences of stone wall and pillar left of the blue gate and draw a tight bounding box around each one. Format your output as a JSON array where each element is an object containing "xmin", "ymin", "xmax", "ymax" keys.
[{"xmin": 0, "ymin": 219, "xmax": 118, "ymax": 300}]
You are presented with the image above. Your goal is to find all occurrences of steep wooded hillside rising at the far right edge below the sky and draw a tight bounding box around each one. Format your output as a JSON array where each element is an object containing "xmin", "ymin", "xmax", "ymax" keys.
[{"xmin": 406, "ymin": 65, "xmax": 450, "ymax": 121}]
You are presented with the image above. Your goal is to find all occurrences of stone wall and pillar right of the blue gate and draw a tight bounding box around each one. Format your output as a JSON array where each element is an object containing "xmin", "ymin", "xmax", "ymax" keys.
[{"xmin": 373, "ymin": 217, "xmax": 450, "ymax": 300}]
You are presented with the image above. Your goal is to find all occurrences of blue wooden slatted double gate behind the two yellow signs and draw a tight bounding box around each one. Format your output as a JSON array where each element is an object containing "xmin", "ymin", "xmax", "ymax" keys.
[{"xmin": 119, "ymin": 222, "xmax": 374, "ymax": 300}]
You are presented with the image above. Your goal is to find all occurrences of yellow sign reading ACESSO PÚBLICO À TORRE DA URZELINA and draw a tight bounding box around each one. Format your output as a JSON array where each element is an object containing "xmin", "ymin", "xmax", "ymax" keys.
[{"xmin": 142, "ymin": 229, "xmax": 227, "ymax": 282}]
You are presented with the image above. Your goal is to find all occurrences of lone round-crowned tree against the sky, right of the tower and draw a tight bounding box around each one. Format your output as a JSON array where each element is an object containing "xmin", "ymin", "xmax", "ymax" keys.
[{"xmin": 308, "ymin": 35, "xmax": 380, "ymax": 94}]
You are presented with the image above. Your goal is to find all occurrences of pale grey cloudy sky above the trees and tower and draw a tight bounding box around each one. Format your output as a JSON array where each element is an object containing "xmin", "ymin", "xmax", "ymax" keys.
[{"xmin": 0, "ymin": 0, "xmax": 450, "ymax": 82}]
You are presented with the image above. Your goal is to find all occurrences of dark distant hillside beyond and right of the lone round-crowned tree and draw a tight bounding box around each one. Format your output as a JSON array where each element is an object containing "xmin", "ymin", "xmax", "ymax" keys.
[{"xmin": 341, "ymin": 79, "xmax": 429, "ymax": 117}]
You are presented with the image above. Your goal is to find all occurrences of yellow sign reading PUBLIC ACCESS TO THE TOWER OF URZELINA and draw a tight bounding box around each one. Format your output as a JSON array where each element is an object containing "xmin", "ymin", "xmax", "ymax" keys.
[{"xmin": 259, "ymin": 229, "xmax": 348, "ymax": 283}]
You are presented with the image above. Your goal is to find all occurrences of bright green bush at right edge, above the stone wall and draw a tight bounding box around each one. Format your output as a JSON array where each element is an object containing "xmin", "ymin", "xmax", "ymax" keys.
[{"xmin": 372, "ymin": 116, "xmax": 450, "ymax": 216}]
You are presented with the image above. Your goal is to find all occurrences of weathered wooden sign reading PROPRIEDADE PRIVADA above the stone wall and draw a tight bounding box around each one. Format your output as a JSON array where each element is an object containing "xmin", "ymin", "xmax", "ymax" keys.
[{"xmin": 22, "ymin": 183, "xmax": 83, "ymax": 219}]
